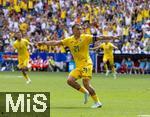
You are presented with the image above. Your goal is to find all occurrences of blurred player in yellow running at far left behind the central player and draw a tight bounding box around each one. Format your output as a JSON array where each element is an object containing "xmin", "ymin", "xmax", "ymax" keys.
[{"xmin": 13, "ymin": 32, "xmax": 31, "ymax": 84}]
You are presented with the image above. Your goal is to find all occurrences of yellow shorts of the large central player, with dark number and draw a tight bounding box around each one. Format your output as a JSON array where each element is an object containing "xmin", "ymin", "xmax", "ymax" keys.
[{"xmin": 69, "ymin": 65, "xmax": 93, "ymax": 79}]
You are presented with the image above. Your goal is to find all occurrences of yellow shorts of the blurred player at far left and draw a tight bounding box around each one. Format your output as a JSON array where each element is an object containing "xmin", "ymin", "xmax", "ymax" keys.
[{"xmin": 18, "ymin": 57, "xmax": 29, "ymax": 69}]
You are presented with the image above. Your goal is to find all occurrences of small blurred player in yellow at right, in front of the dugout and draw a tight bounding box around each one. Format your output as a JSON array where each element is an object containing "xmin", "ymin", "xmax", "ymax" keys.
[{"xmin": 93, "ymin": 40, "xmax": 118, "ymax": 79}]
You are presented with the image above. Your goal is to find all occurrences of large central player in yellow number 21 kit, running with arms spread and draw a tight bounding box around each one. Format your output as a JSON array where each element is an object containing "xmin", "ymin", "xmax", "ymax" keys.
[{"xmin": 38, "ymin": 24, "xmax": 116, "ymax": 108}]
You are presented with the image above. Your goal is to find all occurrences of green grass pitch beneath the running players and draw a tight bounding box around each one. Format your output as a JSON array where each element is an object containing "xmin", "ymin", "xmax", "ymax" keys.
[{"xmin": 0, "ymin": 72, "xmax": 150, "ymax": 117}]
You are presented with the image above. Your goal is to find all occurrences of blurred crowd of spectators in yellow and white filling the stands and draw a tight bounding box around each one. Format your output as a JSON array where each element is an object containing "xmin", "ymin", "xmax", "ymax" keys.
[{"xmin": 0, "ymin": 0, "xmax": 150, "ymax": 53}]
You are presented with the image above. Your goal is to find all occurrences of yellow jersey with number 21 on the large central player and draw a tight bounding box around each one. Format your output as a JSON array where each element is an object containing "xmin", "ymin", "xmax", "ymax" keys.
[{"xmin": 62, "ymin": 34, "xmax": 93, "ymax": 67}]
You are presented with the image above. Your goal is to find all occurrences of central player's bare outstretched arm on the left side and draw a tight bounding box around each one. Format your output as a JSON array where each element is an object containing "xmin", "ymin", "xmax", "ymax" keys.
[{"xmin": 37, "ymin": 41, "xmax": 63, "ymax": 46}]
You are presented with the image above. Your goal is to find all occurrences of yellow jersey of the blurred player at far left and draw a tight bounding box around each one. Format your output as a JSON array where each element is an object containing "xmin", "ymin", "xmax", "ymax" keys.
[{"xmin": 13, "ymin": 39, "xmax": 30, "ymax": 58}]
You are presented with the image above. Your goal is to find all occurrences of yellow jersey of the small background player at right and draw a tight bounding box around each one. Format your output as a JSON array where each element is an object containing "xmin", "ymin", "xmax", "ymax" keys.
[{"xmin": 100, "ymin": 42, "xmax": 114, "ymax": 56}]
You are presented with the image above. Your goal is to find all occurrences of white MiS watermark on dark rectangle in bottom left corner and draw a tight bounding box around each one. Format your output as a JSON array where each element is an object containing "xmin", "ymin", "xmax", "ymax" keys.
[{"xmin": 0, "ymin": 92, "xmax": 50, "ymax": 117}]
